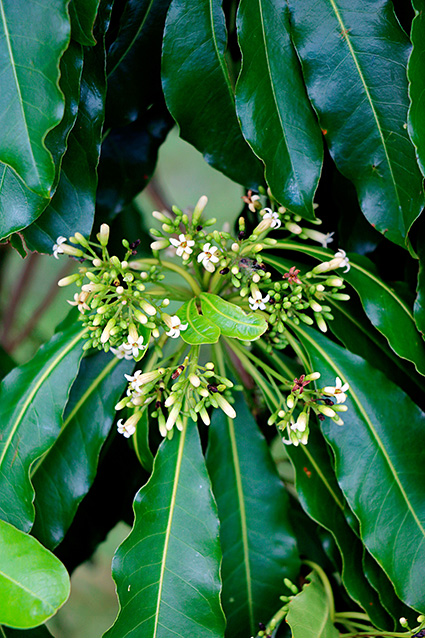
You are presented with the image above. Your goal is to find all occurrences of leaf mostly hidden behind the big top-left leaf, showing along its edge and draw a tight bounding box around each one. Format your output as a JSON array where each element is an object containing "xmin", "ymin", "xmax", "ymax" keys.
[{"xmin": 0, "ymin": 42, "xmax": 83, "ymax": 238}]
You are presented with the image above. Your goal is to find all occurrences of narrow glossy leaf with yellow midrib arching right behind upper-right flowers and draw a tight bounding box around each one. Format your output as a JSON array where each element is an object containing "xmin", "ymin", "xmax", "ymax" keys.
[{"xmin": 264, "ymin": 242, "xmax": 425, "ymax": 374}]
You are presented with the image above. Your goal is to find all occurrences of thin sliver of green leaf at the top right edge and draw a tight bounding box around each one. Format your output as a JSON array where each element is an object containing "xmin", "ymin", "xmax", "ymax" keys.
[{"xmin": 407, "ymin": 0, "xmax": 425, "ymax": 180}]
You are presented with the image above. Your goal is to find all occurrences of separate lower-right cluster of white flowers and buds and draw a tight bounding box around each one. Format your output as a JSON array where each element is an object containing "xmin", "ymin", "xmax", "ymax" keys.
[{"xmin": 268, "ymin": 372, "xmax": 349, "ymax": 446}]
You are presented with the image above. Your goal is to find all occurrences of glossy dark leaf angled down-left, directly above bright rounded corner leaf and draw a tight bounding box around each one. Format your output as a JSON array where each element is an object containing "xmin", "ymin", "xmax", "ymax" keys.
[{"xmin": 31, "ymin": 352, "xmax": 134, "ymax": 549}]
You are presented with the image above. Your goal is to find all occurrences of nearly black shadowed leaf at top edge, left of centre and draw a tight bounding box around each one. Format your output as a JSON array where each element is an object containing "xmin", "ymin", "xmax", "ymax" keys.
[{"xmin": 106, "ymin": 0, "xmax": 170, "ymax": 126}]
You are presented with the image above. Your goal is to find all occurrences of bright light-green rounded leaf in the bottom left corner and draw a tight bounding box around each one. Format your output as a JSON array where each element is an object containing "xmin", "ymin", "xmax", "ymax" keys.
[{"xmin": 0, "ymin": 520, "xmax": 70, "ymax": 631}]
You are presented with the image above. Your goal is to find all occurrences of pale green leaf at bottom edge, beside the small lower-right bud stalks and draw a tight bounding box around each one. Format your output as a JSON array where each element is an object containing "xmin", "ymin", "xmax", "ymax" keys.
[{"xmin": 286, "ymin": 572, "xmax": 339, "ymax": 638}]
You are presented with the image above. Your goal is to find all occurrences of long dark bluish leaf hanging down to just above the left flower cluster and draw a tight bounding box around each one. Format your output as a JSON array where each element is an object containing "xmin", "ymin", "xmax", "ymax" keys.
[{"xmin": 24, "ymin": 40, "xmax": 105, "ymax": 252}]
